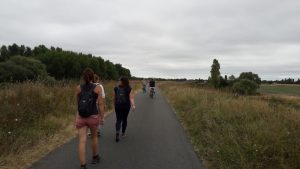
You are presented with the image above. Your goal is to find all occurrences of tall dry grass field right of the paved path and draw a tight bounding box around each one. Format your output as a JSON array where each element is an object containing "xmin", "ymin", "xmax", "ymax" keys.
[{"xmin": 160, "ymin": 82, "xmax": 300, "ymax": 169}]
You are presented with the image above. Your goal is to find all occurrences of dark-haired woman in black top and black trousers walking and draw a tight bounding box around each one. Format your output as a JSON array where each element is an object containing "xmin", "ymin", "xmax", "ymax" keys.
[{"xmin": 113, "ymin": 77, "xmax": 135, "ymax": 142}]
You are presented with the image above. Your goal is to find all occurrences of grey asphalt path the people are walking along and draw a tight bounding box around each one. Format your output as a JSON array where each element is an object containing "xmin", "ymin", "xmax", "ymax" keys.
[{"xmin": 30, "ymin": 91, "xmax": 202, "ymax": 169}]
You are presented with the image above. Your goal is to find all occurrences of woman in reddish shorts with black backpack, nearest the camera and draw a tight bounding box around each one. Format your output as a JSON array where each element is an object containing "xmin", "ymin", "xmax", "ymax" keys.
[{"xmin": 76, "ymin": 68, "xmax": 104, "ymax": 169}]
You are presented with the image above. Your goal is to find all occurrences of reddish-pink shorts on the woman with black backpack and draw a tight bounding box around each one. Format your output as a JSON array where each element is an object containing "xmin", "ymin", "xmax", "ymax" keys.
[{"xmin": 76, "ymin": 115, "xmax": 99, "ymax": 130}]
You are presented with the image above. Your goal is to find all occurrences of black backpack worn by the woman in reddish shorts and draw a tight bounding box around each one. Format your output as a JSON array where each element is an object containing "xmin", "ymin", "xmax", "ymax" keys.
[{"xmin": 78, "ymin": 84, "xmax": 96, "ymax": 117}]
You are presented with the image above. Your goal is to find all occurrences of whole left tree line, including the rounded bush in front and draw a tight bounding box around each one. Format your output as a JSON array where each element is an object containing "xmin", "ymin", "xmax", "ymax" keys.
[{"xmin": 0, "ymin": 44, "xmax": 131, "ymax": 82}]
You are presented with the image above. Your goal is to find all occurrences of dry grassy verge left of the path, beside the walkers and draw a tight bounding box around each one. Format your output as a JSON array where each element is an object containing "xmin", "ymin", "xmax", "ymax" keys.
[{"xmin": 0, "ymin": 81, "xmax": 138, "ymax": 169}]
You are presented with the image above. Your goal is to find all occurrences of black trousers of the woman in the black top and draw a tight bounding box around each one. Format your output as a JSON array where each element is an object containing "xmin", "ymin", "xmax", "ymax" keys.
[{"xmin": 115, "ymin": 107, "xmax": 130, "ymax": 133}]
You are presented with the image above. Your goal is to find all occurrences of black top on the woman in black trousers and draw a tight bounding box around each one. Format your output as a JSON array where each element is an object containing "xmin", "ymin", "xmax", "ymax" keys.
[{"xmin": 114, "ymin": 86, "xmax": 132, "ymax": 108}]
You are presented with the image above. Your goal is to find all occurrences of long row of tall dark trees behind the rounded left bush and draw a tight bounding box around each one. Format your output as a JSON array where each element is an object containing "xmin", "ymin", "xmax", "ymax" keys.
[{"xmin": 0, "ymin": 44, "xmax": 131, "ymax": 79}]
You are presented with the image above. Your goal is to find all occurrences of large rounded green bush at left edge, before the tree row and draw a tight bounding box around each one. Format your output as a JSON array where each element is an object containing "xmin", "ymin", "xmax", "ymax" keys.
[{"xmin": 0, "ymin": 56, "xmax": 47, "ymax": 82}]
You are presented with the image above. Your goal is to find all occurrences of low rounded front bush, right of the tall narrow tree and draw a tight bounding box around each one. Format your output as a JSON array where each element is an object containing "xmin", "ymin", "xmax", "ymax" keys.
[{"xmin": 232, "ymin": 79, "xmax": 259, "ymax": 95}]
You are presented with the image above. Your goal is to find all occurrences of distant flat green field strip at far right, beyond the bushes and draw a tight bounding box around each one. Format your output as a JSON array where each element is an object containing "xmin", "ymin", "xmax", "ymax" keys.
[{"xmin": 259, "ymin": 84, "xmax": 300, "ymax": 96}]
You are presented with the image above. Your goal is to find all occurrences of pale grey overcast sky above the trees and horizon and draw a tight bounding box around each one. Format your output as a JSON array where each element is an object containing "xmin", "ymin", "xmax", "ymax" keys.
[{"xmin": 0, "ymin": 0, "xmax": 300, "ymax": 79}]
